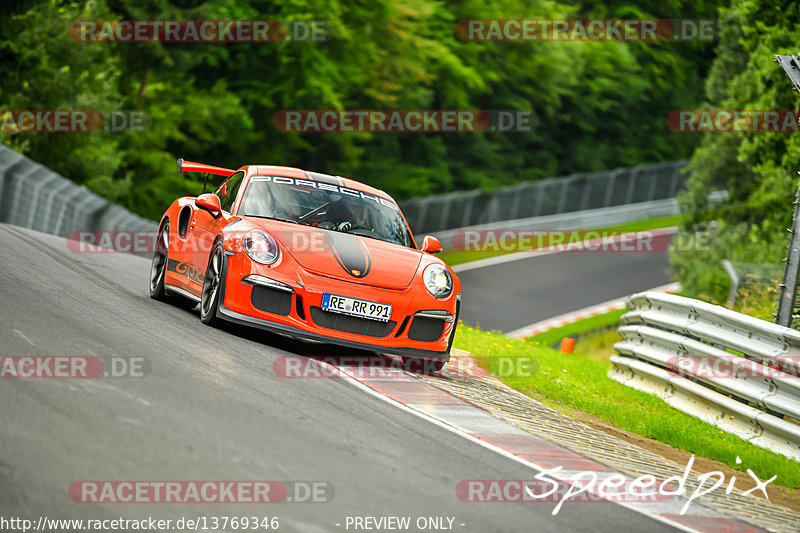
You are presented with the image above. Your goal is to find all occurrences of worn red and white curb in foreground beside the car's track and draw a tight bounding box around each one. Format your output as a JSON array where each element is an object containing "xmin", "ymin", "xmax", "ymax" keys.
[{"xmin": 321, "ymin": 356, "xmax": 767, "ymax": 533}]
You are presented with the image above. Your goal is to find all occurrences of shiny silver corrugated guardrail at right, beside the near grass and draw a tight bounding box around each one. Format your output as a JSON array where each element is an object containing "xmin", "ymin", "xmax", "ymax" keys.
[{"xmin": 609, "ymin": 292, "xmax": 800, "ymax": 460}]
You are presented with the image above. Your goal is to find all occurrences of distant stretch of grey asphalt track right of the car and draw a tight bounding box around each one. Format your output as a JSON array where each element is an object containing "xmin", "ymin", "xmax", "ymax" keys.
[{"xmin": 458, "ymin": 246, "xmax": 672, "ymax": 332}]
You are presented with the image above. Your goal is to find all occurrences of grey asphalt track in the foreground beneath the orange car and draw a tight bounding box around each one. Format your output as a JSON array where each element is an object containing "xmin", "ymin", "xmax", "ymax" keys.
[{"xmin": 0, "ymin": 225, "xmax": 672, "ymax": 532}]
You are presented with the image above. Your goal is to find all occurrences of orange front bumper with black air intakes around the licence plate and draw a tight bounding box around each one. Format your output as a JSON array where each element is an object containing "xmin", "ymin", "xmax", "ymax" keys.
[{"xmin": 217, "ymin": 252, "xmax": 460, "ymax": 361}]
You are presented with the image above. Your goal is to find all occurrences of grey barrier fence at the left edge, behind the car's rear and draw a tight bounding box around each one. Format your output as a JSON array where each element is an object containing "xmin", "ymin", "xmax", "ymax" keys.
[{"xmin": 0, "ymin": 144, "xmax": 157, "ymax": 237}]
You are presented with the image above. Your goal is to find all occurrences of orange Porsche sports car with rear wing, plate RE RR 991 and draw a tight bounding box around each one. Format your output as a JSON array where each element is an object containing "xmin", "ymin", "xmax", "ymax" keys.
[{"xmin": 150, "ymin": 159, "xmax": 461, "ymax": 370}]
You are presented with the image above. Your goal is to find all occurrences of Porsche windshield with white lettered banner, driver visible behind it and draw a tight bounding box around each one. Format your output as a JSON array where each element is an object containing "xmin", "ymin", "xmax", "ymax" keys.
[{"xmin": 238, "ymin": 176, "xmax": 414, "ymax": 247}]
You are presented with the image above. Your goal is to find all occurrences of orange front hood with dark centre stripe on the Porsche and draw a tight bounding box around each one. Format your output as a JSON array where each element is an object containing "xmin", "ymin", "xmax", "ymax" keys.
[{"xmin": 242, "ymin": 219, "xmax": 422, "ymax": 289}]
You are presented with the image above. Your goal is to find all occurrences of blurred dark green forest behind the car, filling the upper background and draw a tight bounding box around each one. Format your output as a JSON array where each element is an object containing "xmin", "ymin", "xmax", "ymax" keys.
[{"xmin": 0, "ymin": 0, "xmax": 720, "ymax": 217}]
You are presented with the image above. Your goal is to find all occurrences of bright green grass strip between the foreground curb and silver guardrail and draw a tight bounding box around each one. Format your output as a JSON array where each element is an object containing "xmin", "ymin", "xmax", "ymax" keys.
[{"xmin": 454, "ymin": 324, "xmax": 800, "ymax": 488}]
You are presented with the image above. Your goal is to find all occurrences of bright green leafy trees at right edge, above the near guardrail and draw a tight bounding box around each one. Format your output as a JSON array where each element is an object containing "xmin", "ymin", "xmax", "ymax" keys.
[{"xmin": 671, "ymin": 0, "xmax": 800, "ymax": 301}]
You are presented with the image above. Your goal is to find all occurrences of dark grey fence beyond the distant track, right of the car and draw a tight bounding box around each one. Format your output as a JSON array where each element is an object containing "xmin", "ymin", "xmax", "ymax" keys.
[{"xmin": 400, "ymin": 159, "xmax": 689, "ymax": 235}]
